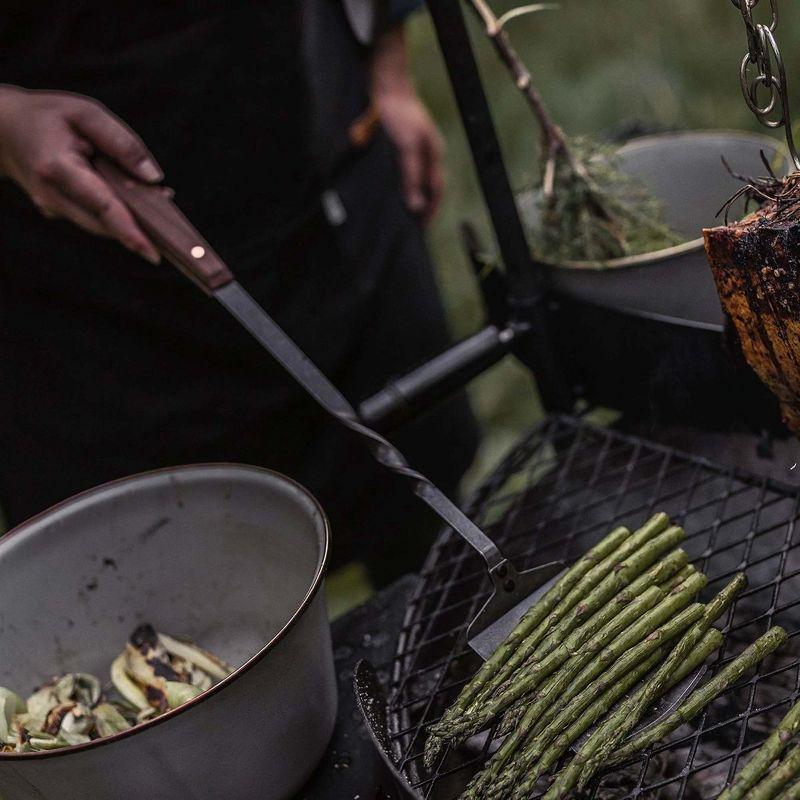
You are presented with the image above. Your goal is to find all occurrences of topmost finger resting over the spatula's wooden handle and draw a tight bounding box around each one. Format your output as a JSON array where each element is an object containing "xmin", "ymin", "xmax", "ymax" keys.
[{"xmin": 70, "ymin": 103, "xmax": 164, "ymax": 183}]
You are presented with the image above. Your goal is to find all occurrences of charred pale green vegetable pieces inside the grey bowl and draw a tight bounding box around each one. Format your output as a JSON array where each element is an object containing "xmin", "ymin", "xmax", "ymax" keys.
[{"xmin": 0, "ymin": 624, "xmax": 233, "ymax": 753}]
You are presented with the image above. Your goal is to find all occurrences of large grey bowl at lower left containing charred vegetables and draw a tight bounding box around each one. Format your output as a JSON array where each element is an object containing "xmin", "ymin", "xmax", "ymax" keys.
[{"xmin": 0, "ymin": 464, "xmax": 336, "ymax": 800}]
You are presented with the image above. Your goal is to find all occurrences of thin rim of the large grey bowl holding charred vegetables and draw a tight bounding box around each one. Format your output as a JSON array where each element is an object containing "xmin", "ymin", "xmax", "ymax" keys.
[{"xmin": 0, "ymin": 461, "xmax": 331, "ymax": 761}]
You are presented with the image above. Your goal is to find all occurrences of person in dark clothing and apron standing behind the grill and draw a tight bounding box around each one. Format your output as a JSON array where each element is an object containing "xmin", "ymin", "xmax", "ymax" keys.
[{"xmin": 0, "ymin": 0, "xmax": 476, "ymax": 582}]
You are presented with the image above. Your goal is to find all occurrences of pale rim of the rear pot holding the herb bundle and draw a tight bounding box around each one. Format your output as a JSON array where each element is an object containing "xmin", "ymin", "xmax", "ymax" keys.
[{"xmin": 541, "ymin": 128, "xmax": 788, "ymax": 272}]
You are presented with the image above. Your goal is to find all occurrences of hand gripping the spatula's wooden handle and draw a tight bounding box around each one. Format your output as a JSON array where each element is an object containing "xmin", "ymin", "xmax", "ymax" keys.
[{"xmin": 0, "ymin": 86, "xmax": 163, "ymax": 264}]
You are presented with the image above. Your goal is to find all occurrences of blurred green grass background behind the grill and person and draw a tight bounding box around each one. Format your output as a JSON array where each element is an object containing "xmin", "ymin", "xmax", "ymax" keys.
[{"xmin": 408, "ymin": 0, "xmax": 800, "ymax": 478}]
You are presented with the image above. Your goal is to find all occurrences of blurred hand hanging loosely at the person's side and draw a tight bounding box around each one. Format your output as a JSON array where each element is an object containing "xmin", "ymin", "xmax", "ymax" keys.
[{"xmin": 371, "ymin": 28, "xmax": 445, "ymax": 224}]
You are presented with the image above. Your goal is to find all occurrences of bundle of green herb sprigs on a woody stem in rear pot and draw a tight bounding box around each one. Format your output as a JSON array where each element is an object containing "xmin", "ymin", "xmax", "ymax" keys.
[{"xmin": 462, "ymin": 0, "xmax": 680, "ymax": 261}]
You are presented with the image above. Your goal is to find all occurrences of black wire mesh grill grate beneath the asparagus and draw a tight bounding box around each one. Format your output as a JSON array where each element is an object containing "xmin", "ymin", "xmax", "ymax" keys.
[{"xmin": 389, "ymin": 417, "xmax": 800, "ymax": 800}]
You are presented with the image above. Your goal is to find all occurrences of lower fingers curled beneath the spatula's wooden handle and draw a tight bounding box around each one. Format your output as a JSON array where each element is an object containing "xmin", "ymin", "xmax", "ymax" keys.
[{"xmin": 42, "ymin": 153, "xmax": 161, "ymax": 264}]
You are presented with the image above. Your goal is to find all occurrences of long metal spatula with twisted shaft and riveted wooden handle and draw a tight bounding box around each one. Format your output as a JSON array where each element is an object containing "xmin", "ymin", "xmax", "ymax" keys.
[{"xmin": 95, "ymin": 158, "xmax": 563, "ymax": 659}]
